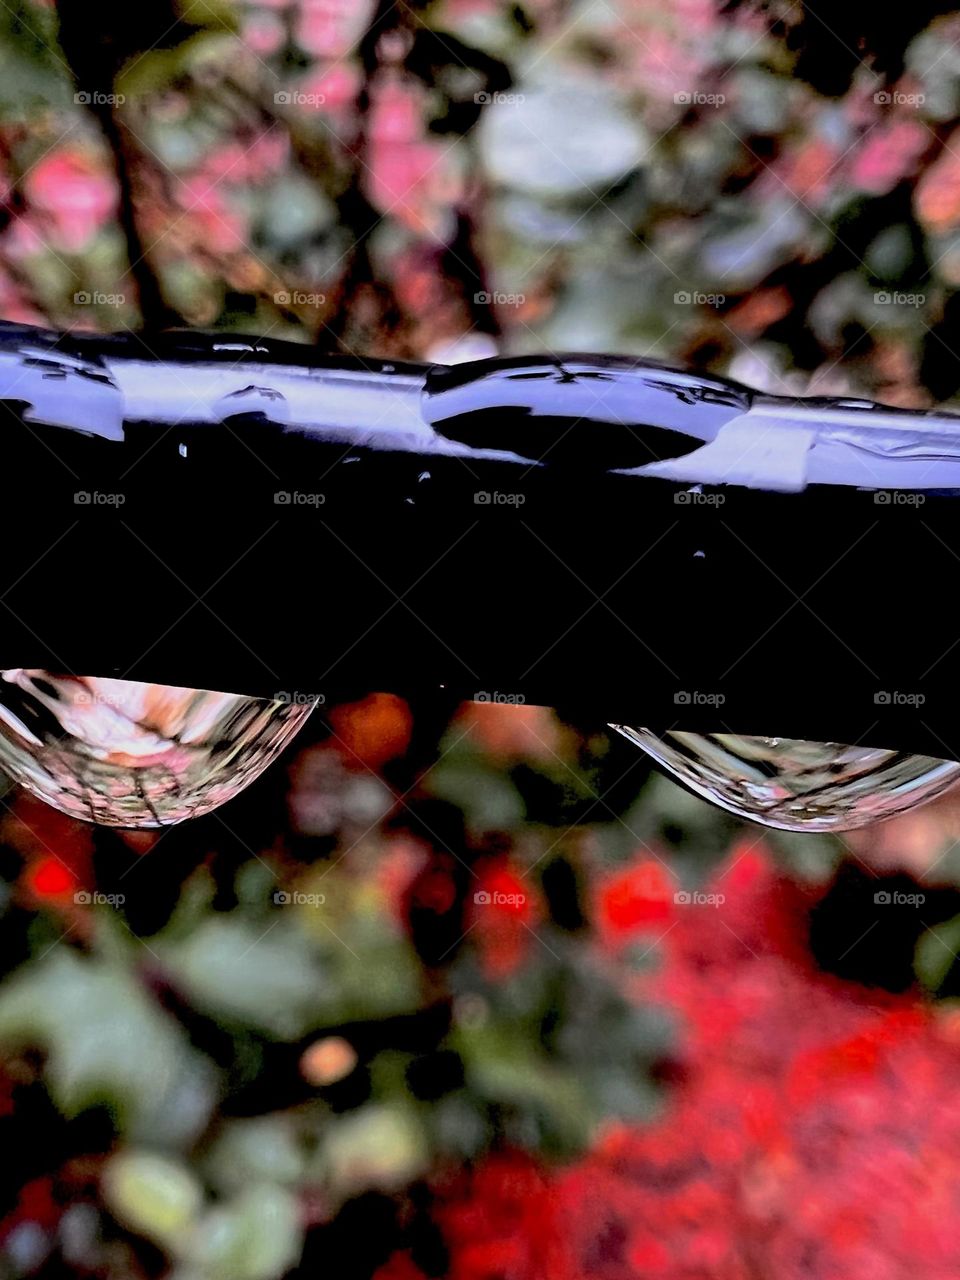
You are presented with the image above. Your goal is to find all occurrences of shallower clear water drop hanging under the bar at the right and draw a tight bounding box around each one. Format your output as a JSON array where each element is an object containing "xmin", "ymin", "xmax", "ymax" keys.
[{"xmin": 611, "ymin": 724, "xmax": 960, "ymax": 831}]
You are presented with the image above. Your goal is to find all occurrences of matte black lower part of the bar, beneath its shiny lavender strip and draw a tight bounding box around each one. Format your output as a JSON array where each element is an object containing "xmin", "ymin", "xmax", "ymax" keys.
[{"xmin": 0, "ymin": 325, "xmax": 960, "ymax": 756}]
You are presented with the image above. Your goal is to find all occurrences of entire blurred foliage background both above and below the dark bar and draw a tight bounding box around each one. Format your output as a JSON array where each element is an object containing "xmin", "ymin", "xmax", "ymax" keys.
[{"xmin": 7, "ymin": 0, "xmax": 960, "ymax": 1280}]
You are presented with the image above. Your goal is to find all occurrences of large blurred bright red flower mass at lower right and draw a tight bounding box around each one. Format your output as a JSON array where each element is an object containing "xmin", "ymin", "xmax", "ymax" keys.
[{"xmin": 378, "ymin": 841, "xmax": 960, "ymax": 1280}]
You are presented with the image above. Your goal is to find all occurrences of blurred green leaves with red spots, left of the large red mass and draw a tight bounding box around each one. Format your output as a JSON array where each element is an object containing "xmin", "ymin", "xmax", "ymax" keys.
[{"xmin": 0, "ymin": 695, "xmax": 686, "ymax": 1280}]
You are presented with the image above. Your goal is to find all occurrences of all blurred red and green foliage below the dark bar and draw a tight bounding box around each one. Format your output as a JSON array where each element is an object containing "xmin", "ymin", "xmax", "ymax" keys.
[{"xmin": 0, "ymin": 695, "xmax": 960, "ymax": 1280}]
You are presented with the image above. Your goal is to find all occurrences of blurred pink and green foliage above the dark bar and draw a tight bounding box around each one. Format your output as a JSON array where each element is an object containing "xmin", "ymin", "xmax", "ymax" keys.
[{"xmin": 0, "ymin": 0, "xmax": 960, "ymax": 404}]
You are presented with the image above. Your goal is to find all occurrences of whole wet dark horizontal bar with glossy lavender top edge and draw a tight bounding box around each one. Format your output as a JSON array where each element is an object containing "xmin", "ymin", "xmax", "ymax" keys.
[{"xmin": 0, "ymin": 326, "xmax": 960, "ymax": 758}]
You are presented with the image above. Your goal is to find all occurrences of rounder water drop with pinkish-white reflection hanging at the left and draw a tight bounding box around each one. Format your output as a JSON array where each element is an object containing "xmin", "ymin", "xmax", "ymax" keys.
[{"xmin": 0, "ymin": 668, "xmax": 314, "ymax": 827}]
